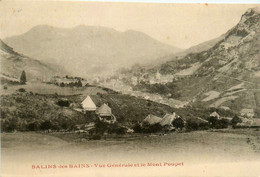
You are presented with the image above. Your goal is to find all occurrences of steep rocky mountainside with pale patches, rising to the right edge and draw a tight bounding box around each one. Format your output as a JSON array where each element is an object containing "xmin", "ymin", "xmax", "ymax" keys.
[{"xmin": 115, "ymin": 8, "xmax": 260, "ymax": 117}]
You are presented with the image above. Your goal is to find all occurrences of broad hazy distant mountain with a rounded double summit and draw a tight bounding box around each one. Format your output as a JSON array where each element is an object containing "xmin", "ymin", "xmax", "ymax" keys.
[{"xmin": 4, "ymin": 25, "xmax": 181, "ymax": 75}]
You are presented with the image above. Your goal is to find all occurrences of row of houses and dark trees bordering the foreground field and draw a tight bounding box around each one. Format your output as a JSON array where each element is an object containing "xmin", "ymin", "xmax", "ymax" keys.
[{"xmin": 53, "ymin": 92, "xmax": 257, "ymax": 138}]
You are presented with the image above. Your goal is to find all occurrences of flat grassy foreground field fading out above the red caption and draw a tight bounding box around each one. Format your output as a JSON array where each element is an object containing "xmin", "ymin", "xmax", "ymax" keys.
[{"xmin": 1, "ymin": 129, "xmax": 260, "ymax": 161}]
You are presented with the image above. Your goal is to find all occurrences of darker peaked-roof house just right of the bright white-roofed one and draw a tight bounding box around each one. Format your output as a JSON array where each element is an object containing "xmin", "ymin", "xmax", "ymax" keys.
[{"xmin": 96, "ymin": 103, "xmax": 116, "ymax": 124}]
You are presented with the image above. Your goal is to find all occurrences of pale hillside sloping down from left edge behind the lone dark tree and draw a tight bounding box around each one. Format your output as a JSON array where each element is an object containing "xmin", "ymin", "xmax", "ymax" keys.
[{"xmin": 0, "ymin": 40, "xmax": 66, "ymax": 81}]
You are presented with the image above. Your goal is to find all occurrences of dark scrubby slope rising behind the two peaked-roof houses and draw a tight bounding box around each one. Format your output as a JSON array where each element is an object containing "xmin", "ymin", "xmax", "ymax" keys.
[{"xmin": 1, "ymin": 84, "xmax": 175, "ymax": 131}]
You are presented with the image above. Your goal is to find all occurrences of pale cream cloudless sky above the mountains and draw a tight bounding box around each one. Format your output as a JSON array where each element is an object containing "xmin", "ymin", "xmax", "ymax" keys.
[{"xmin": 0, "ymin": 0, "xmax": 259, "ymax": 49}]
